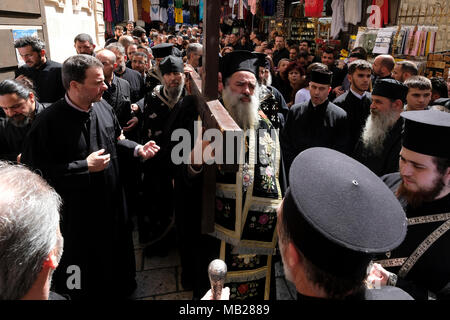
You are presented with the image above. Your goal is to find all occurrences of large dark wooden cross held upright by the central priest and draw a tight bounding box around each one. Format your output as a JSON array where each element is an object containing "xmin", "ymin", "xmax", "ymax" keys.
[{"xmin": 187, "ymin": 0, "xmax": 242, "ymax": 233}]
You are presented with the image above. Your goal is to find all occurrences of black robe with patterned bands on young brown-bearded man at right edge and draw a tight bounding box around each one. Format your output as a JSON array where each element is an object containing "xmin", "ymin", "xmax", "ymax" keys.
[{"xmin": 376, "ymin": 172, "xmax": 450, "ymax": 300}]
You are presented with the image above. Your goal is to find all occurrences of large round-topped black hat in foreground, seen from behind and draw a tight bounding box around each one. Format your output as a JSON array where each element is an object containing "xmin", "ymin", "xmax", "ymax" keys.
[{"xmin": 283, "ymin": 148, "xmax": 407, "ymax": 278}]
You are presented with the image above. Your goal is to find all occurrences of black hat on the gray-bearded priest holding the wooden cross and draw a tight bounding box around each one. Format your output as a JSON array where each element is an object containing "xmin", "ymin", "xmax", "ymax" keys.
[{"xmin": 220, "ymin": 50, "xmax": 259, "ymax": 83}]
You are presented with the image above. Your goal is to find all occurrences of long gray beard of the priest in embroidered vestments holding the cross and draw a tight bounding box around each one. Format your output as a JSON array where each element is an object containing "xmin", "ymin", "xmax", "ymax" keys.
[{"xmin": 222, "ymin": 85, "xmax": 260, "ymax": 131}]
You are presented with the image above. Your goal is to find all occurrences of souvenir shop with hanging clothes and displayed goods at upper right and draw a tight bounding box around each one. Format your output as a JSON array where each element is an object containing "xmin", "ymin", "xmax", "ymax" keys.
[{"xmin": 249, "ymin": 0, "xmax": 450, "ymax": 77}]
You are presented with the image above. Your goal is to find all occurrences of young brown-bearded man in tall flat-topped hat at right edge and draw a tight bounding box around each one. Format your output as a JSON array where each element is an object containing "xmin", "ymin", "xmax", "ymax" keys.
[{"xmin": 373, "ymin": 110, "xmax": 450, "ymax": 300}]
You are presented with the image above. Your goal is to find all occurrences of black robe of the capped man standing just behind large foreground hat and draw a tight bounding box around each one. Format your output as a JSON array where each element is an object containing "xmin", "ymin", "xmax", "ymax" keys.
[{"xmin": 280, "ymin": 100, "xmax": 350, "ymax": 175}]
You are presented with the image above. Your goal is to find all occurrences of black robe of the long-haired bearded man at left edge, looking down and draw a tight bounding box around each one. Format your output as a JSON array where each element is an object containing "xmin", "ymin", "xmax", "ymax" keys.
[{"xmin": 0, "ymin": 101, "xmax": 45, "ymax": 161}]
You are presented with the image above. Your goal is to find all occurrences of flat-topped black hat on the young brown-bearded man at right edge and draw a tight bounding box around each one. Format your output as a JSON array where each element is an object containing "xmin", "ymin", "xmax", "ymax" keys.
[{"xmin": 400, "ymin": 110, "xmax": 450, "ymax": 159}]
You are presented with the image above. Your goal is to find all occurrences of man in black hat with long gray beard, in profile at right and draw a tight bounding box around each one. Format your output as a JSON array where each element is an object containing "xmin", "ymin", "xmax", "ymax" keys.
[{"xmin": 353, "ymin": 79, "xmax": 408, "ymax": 176}]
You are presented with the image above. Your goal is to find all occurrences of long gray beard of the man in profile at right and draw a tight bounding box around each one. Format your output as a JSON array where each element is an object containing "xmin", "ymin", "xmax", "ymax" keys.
[{"xmin": 361, "ymin": 111, "xmax": 398, "ymax": 156}]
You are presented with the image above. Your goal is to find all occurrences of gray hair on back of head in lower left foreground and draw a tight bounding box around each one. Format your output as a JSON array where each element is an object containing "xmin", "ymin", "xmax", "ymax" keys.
[{"xmin": 0, "ymin": 161, "xmax": 62, "ymax": 300}]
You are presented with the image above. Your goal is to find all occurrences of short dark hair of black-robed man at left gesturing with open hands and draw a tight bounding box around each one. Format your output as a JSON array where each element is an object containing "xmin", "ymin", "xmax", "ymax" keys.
[{"xmin": 62, "ymin": 54, "xmax": 103, "ymax": 90}]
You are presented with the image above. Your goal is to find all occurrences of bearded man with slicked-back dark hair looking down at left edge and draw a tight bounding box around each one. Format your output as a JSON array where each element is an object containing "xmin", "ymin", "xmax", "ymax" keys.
[{"xmin": 0, "ymin": 79, "xmax": 45, "ymax": 162}]
